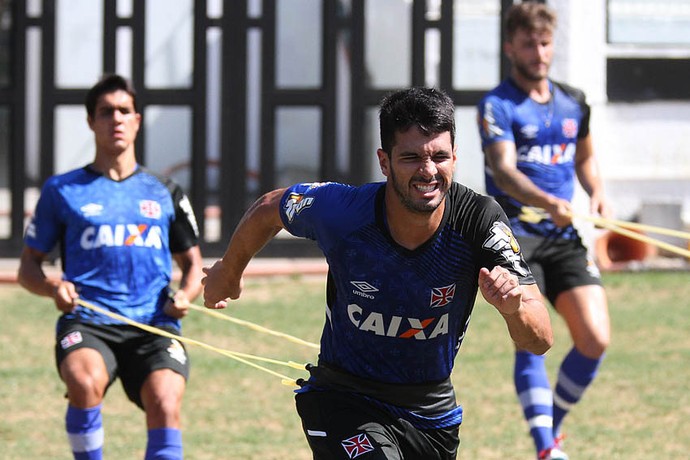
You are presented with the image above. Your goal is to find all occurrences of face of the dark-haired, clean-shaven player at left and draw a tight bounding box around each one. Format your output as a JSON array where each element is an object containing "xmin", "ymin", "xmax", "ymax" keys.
[{"xmin": 89, "ymin": 90, "xmax": 141, "ymax": 153}]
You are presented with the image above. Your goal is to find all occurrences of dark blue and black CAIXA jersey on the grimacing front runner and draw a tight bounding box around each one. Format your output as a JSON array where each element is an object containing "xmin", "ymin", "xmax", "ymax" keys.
[{"xmin": 281, "ymin": 183, "xmax": 534, "ymax": 426}]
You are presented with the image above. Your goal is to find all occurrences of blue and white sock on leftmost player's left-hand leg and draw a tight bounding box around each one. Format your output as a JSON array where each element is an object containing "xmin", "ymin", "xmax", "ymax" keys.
[{"xmin": 65, "ymin": 404, "xmax": 103, "ymax": 460}]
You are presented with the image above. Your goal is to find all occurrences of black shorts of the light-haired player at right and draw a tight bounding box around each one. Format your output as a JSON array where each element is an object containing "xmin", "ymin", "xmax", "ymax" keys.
[{"xmin": 518, "ymin": 236, "xmax": 601, "ymax": 305}]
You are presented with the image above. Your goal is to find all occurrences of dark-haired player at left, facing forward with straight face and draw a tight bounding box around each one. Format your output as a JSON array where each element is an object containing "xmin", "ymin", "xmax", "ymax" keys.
[{"xmin": 19, "ymin": 75, "xmax": 203, "ymax": 459}]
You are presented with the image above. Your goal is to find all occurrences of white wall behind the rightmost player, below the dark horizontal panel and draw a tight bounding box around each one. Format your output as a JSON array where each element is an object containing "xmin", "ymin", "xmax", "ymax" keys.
[{"xmin": 548, "ymin": 0, "xmax": 690, "ymax": 225}]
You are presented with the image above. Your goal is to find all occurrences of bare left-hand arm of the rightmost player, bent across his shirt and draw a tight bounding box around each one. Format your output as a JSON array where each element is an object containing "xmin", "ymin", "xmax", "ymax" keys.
[{"xmin": 484, "ymin": 141, "xmax": 572, "ymax": 227}]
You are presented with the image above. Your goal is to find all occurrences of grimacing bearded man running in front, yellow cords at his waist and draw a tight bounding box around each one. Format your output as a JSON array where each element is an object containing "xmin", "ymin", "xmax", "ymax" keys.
[{"xmin": 202, "ymin": 88, "xmax": 552, "ymax": 459}]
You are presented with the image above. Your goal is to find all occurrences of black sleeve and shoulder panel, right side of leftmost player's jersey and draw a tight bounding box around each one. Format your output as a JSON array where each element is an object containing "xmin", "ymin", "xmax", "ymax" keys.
[{"xmin": 138, "ymin": 166, "xmax": 199, "ymax": 253}]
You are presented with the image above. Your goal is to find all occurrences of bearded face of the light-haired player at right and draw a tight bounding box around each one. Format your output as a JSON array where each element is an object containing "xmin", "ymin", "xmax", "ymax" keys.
[{"xmin": 505, "ymin": 29, "xmax": 553, "ymax": 81}]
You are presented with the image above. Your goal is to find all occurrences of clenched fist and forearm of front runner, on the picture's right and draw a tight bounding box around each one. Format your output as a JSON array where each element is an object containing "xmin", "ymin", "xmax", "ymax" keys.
[{"xmin": 479, "ymin": 266, "xmax": 553, "ymax": 355}]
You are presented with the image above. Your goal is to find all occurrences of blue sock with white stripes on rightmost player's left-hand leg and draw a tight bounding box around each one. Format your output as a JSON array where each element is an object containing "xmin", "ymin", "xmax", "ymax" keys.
[{"xmin": 513, "ymin": 351, "xmax": 553, "ymax": 453}]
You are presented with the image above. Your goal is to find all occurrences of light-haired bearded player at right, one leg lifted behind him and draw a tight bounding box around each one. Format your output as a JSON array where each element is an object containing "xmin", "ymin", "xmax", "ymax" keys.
[{"xmin": 478, "ymin": 2, "xmax": 610, "ymax": 459}]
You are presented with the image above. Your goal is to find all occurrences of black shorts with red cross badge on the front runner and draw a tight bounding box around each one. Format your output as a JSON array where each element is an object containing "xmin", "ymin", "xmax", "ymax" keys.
[{"xmin": 295, "ymin": 390, "xmax": 460, "ymax": 460}]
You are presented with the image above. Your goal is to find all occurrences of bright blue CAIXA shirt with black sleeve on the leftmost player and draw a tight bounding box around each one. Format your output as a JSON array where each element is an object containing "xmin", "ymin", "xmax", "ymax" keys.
[{"xmin": 25, "ymin": 166, "xmax": 198, "ymax": 329}]
